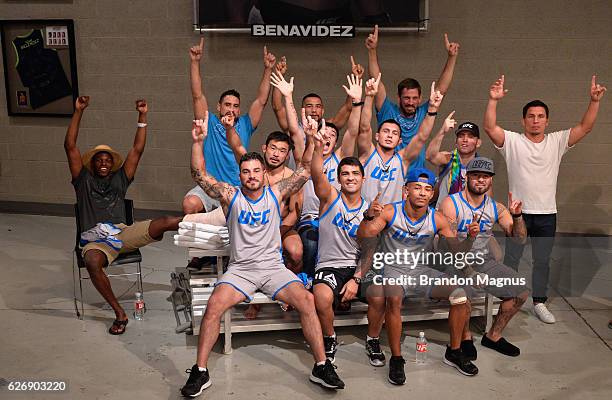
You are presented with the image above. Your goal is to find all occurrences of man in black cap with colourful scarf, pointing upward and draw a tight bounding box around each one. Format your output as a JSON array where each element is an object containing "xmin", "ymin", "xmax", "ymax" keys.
[{"xmin": 425, "ymin": 116, "xmax": 482, "ymax": 210}]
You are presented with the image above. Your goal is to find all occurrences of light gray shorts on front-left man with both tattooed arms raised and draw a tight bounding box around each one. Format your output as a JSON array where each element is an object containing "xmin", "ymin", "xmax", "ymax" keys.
[{"xmin": 215, "ymin": 263, "xmax": 302, "ymax": 303}]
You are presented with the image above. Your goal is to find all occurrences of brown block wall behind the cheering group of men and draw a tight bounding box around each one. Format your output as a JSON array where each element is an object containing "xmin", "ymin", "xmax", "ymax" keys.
[{"xmin": 0, "ymin": 0, "xmax": 612, "ymax": 234}]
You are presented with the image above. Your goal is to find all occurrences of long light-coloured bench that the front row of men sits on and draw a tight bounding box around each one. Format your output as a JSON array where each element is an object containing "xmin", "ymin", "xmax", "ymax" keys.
[{"xmin": 189, "ymin": 248, "xmax": 498, "ymax": 354}]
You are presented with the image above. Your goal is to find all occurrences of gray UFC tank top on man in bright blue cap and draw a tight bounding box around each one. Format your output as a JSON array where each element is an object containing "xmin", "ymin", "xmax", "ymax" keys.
[{"xmin": 379, "ymin": 201, "xmax": 438, "ymax": 270}]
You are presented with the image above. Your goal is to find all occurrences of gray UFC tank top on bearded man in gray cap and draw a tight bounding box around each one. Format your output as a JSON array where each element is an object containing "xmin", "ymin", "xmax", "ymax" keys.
[{"xmin": 450, "ymin": 192, "xmax": 498, "ymax": 258}]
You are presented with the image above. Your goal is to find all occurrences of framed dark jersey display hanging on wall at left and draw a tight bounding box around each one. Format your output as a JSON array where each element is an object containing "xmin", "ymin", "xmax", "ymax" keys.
[{"xmin": 0, "ymin": 19, "xmax": 79, "ymax": 117}]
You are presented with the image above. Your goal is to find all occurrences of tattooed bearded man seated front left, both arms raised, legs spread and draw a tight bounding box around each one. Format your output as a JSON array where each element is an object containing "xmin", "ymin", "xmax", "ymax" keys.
[{"xmin": 181, "ymin": 113, "xmax": 344, "ymax": 397}]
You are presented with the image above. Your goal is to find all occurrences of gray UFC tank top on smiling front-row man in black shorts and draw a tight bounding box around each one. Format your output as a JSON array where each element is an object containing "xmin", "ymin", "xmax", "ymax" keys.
[{"xmin": 315, "ymin": 193, "xmax": 368, "ymax": 270}]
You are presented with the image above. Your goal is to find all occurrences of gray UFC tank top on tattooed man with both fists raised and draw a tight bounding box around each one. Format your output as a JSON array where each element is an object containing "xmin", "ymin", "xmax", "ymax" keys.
[{"xmin": 227, "ymin": 186, "xmax": 283, "ymax": 270}]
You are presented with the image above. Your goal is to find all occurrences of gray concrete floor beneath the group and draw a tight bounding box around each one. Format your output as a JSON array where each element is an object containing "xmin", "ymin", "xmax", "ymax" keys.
[{"xmin": 0, "ymin": 214, "xmax": 612, "ymax": 400}]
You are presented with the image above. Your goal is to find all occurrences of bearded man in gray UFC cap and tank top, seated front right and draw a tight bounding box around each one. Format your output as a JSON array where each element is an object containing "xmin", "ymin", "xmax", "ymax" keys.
[{"xmin": 441, "ymin": 157, "xmax": 529, "ymax": 360}]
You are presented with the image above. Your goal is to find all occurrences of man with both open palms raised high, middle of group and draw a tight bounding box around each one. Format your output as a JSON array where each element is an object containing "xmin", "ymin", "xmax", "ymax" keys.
[{"xmin": 272, "ymin": 73, "xmax": 363, "ymax": 277}]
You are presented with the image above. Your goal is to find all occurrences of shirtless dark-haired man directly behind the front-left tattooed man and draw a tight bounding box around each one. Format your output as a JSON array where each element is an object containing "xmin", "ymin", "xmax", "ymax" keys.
[{"xmin": 225, "ymin": 115, "xmax": 303, "ymax": 319}]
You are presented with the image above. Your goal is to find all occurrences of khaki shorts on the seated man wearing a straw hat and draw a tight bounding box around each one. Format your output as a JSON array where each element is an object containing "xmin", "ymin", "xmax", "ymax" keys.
[{"xmin": 81, "ymin": 219, "xmax": 158, "ymax": 266}]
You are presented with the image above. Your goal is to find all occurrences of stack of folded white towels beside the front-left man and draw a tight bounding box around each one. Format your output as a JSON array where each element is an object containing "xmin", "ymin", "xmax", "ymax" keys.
[{"xmin": 174, "ymin": 221, "xmax": 229, "ymax": 250}]
